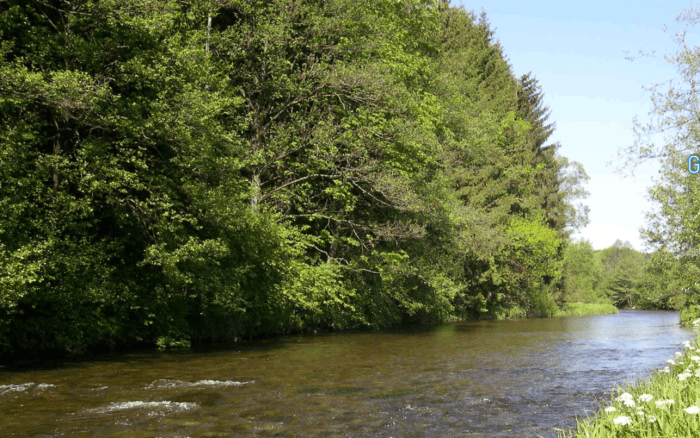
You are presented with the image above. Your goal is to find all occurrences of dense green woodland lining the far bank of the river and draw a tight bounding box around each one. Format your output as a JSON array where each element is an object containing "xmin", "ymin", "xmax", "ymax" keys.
[{"xmin": 0, "ymin": 0, "xmax": 688, "ymax": 356}]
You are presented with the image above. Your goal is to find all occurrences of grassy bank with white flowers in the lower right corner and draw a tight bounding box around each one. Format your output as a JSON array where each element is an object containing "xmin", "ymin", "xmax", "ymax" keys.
[{"xmin": 559, "ymin": 326, "xmax": 700, "ymax": 438}]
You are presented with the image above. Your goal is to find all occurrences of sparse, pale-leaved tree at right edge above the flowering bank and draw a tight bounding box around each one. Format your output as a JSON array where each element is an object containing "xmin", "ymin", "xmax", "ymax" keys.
[{"xmin": 620, "ymin": 5, "xmax": 700, "ymax": 321}]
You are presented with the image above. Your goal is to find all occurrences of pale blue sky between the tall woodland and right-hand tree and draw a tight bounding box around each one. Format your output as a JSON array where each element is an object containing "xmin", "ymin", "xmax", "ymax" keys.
[{"xmin": 452, "ymin": 0, "xmax": 700, "ymax": 251}]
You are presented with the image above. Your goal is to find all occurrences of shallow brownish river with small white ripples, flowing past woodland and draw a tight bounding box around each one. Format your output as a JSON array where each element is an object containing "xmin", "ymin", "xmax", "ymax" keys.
[{"xmin": 0, "ymin": 311, "xmax": 695, "ymax": 438}]
